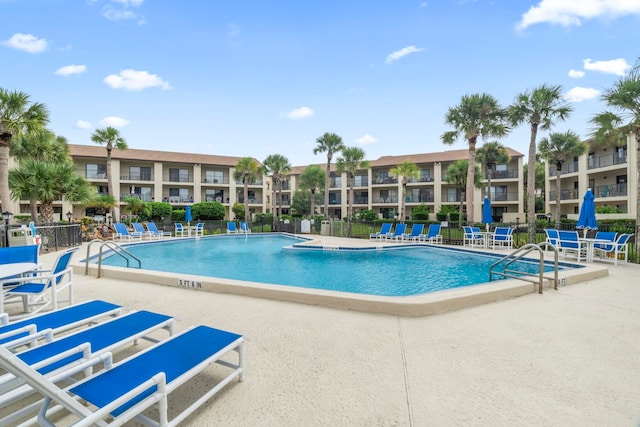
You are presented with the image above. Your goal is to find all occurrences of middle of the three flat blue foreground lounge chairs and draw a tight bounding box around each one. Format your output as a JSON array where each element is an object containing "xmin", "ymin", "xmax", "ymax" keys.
[{"xmin": 0, "ymin": 311, "xmax": 174, "ymax": 425}]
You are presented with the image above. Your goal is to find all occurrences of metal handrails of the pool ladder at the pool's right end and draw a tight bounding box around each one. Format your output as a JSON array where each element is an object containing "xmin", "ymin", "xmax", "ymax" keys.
[{"xmin": 489, "ymin": 242, "xmax": 558, "ymax": 294}]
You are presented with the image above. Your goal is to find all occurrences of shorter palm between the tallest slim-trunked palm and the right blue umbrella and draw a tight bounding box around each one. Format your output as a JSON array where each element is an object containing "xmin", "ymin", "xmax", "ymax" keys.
[{"xmin": 538, "ymin": 130, "xmax": 588, "ymax": 225}]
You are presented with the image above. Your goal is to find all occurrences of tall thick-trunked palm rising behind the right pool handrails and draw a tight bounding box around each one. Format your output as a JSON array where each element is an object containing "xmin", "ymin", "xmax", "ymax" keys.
[{"xmin": 509, "ymin": 84, "xmax": 573, "ymax": 243}]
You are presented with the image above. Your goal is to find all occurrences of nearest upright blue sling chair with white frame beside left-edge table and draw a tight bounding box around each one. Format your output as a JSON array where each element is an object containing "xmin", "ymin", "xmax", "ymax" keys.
[{"xmin": 4, "ymin": 248, "xmax": 78, "ymax": 319}]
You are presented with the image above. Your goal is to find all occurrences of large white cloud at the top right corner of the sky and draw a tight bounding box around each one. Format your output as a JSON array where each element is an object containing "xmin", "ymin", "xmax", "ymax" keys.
[{"xmin": 516, "ymin": 0, "xmax": 640, "ymax": 30}]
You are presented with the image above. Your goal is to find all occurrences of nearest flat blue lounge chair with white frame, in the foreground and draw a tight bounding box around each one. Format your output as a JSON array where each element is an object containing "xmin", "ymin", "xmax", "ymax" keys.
[{"xmin": 0, "ymin": 326, "xmax": 244, "ymax": 426}]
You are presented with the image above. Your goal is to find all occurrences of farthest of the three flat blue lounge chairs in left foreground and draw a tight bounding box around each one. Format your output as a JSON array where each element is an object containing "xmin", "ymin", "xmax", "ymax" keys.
[{"xmin": 0, "ymin": 300, "xmax": 122, "ymax": 348}]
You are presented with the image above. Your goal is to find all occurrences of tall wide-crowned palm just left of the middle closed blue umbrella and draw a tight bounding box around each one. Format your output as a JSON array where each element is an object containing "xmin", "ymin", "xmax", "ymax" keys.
[{"xmin": 441, "ymin": 93, "xmax": 509, "ymax": 223}]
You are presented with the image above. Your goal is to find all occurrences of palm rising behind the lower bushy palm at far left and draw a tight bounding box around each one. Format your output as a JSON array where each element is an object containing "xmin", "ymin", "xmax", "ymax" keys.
[{"xmin": 10, "ymin": 130, "xmax": 70, "ymax": 223}]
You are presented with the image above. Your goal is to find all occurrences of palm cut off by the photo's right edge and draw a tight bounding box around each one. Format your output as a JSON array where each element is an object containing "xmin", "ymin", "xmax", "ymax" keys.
[{"xmin": 591, "ymin": 59, "xmax": 640, "ymax": 229}]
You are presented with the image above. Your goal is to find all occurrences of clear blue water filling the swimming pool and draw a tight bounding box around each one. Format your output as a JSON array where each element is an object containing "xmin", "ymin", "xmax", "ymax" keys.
[{"xmin": 103, "ymin": 235, "xmax": 564, "ymax": 296}]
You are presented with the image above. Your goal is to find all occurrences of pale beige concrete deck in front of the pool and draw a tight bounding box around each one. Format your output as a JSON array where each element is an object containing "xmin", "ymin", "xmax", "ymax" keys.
[{"xmin": 23, "ymin": 239, "xmax": 640, "ymax": 426}]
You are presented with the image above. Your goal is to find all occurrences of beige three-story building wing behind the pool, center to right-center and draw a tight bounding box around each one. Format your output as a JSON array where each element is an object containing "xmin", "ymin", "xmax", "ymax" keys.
[{"xmin": 281, "ymin": 149, "xmax": 524, "ymax": 221}]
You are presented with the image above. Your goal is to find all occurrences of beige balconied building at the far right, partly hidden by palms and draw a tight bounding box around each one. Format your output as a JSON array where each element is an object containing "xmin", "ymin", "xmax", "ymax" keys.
[{"xmin": 545, "ymin": 135, "xmax": 638, "ymax": 218}]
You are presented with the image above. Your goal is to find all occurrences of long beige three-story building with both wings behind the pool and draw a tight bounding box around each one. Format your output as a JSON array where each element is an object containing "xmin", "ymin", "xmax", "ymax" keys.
[{"xmin": 3, "ymin": 144, "xmax": 524, "ymax": 221}]
